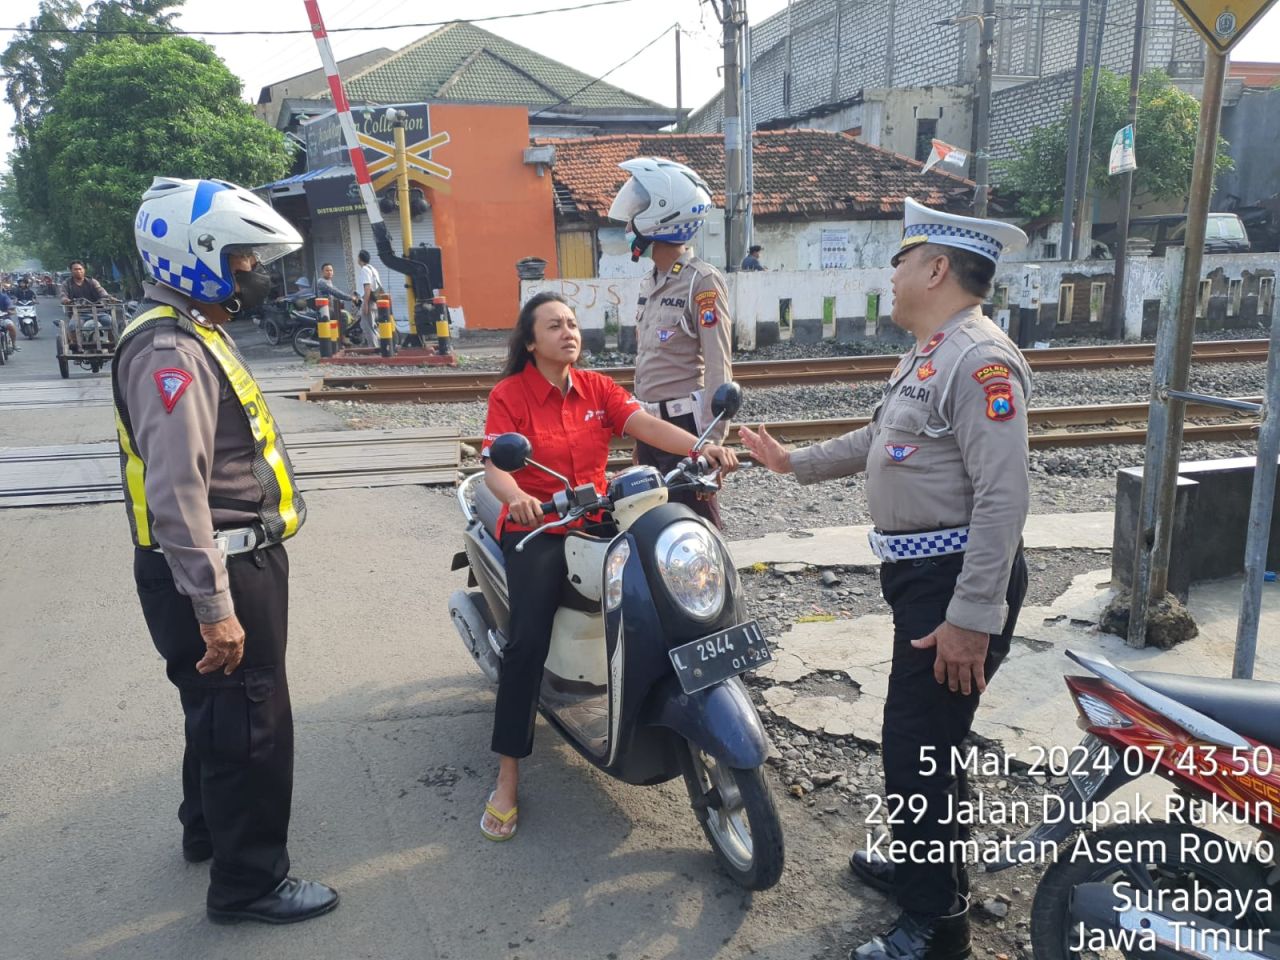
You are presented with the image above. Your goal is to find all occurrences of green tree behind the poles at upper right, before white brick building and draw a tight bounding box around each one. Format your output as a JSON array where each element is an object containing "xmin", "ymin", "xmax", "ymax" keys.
[{"xmin": 996, "ymin": 69, "xmax": 1233, "ymax": 219}]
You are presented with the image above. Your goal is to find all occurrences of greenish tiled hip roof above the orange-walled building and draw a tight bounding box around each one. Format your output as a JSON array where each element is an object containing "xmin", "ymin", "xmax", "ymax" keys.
[{"xmin": 346, "ymin": 23, "xmax": 669, "ymax": 113}]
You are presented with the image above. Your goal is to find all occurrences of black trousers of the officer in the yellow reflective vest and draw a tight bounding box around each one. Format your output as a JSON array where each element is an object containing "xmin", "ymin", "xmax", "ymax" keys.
[{"xmin": 133, "ymin": 547, "xmax": 293, "ymax": 909}]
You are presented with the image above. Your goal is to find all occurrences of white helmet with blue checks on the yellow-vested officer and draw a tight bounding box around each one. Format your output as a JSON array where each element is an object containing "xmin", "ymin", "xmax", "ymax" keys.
[{"xmin": 133, "ymin": 177, "xmax": 302, "ymax": 305}]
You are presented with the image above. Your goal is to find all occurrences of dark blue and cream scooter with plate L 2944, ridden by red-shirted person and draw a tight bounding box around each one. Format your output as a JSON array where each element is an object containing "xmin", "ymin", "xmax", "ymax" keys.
[{"xmin": 449, "ymin": 383, "xmax": 783, "ymax": 890}]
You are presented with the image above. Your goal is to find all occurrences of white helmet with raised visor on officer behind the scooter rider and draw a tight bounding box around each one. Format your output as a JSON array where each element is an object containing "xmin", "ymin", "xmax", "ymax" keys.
[{"xmin": 609, "ymin": 156, "xmax": 712, "ymax": 252}]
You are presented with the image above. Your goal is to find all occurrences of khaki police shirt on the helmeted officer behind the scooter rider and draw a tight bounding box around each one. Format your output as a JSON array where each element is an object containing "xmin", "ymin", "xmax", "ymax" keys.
[{"xmin": 635, "ymin": 250, "xmax": 733, "ymax": 443}]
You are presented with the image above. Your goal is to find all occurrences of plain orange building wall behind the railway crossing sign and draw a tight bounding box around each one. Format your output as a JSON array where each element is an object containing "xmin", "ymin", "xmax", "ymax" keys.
[{"xmin": 430, "ymin": 104, "xmax": 556, "ymax": 330}]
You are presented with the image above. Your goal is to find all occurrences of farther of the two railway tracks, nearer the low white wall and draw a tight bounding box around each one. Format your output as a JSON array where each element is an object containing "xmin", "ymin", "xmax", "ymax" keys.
[{"xmin": 302, "ymin": 340, "xmax": 1268, "ymax": 403}]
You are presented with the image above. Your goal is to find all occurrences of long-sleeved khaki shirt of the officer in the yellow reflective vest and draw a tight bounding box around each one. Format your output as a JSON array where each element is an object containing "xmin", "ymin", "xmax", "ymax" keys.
[{"xmin": 114, "ymin": 284, "xmax": 287, "ymax": 623}]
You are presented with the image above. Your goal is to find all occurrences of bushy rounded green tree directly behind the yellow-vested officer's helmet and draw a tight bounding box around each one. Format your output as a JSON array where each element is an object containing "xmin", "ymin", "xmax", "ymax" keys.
[{"xmin": 20, "ymin": 37, "xmax": 289, "ymax": 288}]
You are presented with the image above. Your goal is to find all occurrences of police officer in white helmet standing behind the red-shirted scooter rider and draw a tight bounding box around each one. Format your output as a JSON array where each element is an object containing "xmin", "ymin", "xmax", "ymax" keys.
[{"xmin": 609, "ymin": 156, "xmax": 733, "ymax": 527}]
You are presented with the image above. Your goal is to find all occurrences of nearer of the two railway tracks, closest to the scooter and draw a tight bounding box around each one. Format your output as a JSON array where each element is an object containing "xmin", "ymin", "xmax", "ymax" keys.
[{"xmin": 462, "ymin": 397, "xmax": 1262, "ymax": 462}]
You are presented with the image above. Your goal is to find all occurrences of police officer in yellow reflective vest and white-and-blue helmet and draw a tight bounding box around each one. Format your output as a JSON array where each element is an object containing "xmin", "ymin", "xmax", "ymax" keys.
[{"xmin": 111, "ymin": 177, "xmax": 338, "ymax": 923}]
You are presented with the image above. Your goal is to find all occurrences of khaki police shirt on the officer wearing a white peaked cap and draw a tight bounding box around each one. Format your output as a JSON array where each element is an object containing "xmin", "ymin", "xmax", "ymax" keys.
[{"xmin": 791, "ymin": 307, "xmax": 1032, "ymax": 634}]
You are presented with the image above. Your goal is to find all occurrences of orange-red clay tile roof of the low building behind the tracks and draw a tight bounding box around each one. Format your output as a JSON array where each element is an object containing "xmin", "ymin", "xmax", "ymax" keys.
[{"xmin": 545, "ymin": 129, "xmax": 974, "ymax": 220}]
